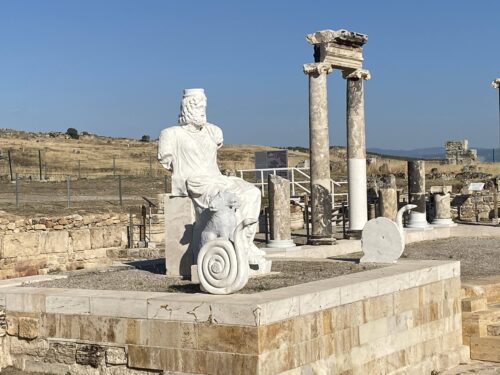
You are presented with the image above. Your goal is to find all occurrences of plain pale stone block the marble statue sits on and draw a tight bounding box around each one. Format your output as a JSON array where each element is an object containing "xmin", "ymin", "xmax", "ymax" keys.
[{"xmin": 164, "ymin": 194, "xmax": 196, "ymax": 278}]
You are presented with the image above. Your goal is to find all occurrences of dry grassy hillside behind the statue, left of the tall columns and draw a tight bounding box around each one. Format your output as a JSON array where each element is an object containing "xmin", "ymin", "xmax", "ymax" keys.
[{"xmin": 0, "ymin": 132, "xmax": 308, "ymax": 179}]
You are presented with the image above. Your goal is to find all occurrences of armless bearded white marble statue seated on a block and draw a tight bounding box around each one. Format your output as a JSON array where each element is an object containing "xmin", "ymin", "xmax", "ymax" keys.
[{"xmin": 158, "ymin": 89, "xmax": 264, "ymax": 264}]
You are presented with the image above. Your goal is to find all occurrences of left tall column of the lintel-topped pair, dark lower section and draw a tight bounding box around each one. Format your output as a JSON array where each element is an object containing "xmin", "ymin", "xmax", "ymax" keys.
[{"xmin": 304, "ymin": 63, "xmax": 333, "ymax": 243}]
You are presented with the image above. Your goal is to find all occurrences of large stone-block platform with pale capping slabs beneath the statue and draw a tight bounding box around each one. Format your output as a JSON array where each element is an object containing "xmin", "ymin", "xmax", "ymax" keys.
[{"xmin": 0, "ymin": 261, "xmax": 469, "ymax": 375}]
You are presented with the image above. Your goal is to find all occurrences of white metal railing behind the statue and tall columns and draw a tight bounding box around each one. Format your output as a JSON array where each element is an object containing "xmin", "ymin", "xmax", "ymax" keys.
[{"xmin": 237, "ymin": 168, "xmax": 349, "ymax": 208}]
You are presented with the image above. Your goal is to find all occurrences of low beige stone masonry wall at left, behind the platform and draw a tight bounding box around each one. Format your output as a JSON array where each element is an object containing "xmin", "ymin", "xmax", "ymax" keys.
[{"xmin": 0, "ymin": 214, "xmax": 128, "ymax": 280}]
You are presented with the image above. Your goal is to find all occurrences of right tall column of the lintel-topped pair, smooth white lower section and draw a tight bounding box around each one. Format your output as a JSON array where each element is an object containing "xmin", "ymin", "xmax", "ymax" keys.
[{"xmin": 343, "ymin": 69, "xmax": 370, "ymax": 231}]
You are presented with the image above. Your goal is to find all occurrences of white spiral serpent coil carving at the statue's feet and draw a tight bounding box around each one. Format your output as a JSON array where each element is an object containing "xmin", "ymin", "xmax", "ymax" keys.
[{"xmin": 197, "ymin": 219, "xmax": 257, "ymax": 294}]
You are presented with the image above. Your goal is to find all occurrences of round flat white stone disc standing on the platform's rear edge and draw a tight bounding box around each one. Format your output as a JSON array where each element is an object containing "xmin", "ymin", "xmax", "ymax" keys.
[{"xmin": 361, "ymin": 217, "xmax": 405, "ymax": 263}]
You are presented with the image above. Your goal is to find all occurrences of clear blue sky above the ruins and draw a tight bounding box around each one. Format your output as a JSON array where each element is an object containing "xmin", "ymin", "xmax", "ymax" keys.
[{"xmin": 0, "ymin": 0, "xmax": 500, "ymax": 149}]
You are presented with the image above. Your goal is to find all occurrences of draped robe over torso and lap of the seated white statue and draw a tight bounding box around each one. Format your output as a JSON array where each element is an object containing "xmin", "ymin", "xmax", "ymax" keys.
[{"xmin": 158, "ymin": 123, "xmax": 261, "ymax": 222}]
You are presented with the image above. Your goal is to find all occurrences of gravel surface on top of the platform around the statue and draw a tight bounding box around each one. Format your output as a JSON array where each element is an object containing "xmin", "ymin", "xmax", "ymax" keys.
[{"xmin": 29, "ymin": 259, "xmax": 381, "ymax": 293}]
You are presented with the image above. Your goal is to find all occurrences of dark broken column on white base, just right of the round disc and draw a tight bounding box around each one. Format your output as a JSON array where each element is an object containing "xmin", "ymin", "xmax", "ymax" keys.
[{"xmin": 407, "ymin": 160, "xmax": 429, "ymax": 229}]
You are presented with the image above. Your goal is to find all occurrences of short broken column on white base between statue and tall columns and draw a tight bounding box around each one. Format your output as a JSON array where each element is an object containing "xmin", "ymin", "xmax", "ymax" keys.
[{"xmin": 267, "ymin": 175, "xmax": 295, "ymax": 248}]
